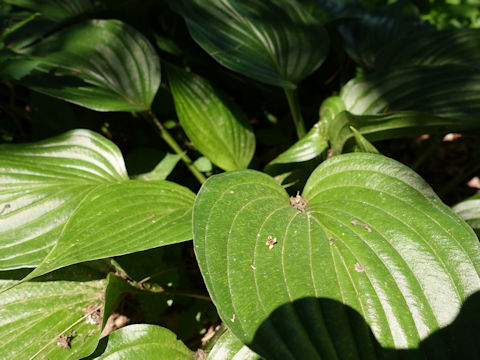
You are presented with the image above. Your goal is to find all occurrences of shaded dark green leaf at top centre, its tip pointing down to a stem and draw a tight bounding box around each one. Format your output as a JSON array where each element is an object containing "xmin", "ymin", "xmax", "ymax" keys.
[{"xmin": 170, "ymin": 0, "xmax": 329, "ymax": 89}]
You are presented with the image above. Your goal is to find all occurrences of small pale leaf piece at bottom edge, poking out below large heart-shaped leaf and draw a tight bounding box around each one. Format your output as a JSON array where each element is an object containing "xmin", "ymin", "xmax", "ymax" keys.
[{"xmin": 207, "ymin": 330, "xmax": 261, "ymax": 360}]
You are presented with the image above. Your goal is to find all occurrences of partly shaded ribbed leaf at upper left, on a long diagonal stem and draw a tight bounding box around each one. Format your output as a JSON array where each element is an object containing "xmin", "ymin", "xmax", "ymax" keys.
[{"xmin": 10, "ymin": 20, "xmax": 160, "ymax": 111}]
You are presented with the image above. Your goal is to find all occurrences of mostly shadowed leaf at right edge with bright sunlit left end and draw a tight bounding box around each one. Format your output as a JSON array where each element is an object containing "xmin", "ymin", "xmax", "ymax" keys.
[{"xmin": 341, "ymin": 65, "xmax": 480, "ymax": 116}]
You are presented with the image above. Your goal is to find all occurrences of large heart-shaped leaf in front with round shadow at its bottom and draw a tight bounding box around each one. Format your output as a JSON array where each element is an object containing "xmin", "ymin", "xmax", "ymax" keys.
[{"xmin": 193, "ymin": 153, "xmax": 480, "ymax": 359}]
